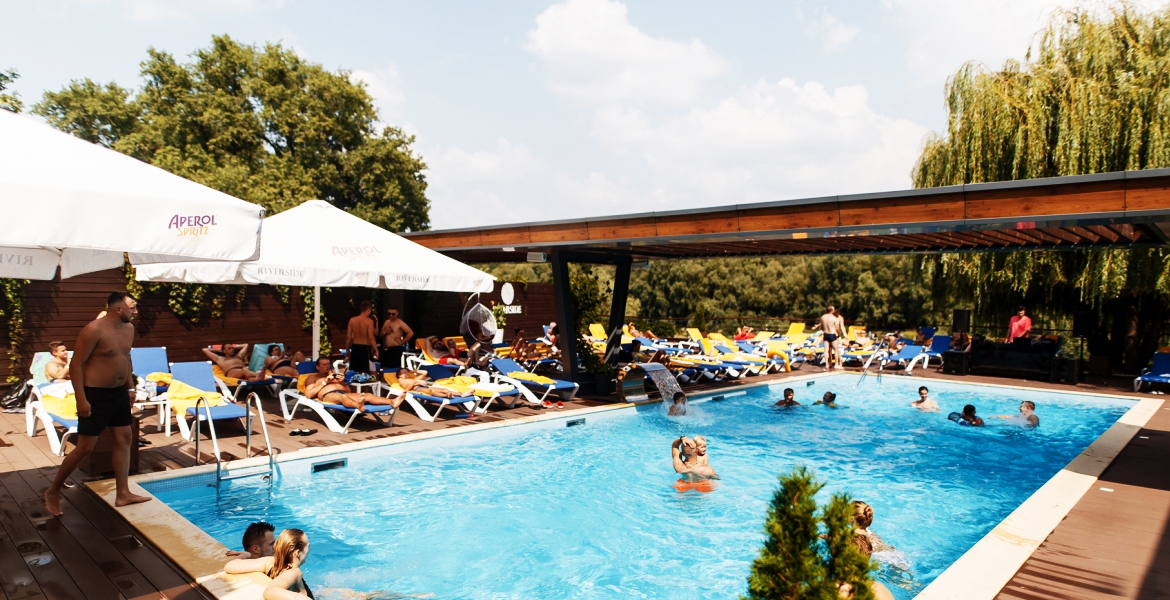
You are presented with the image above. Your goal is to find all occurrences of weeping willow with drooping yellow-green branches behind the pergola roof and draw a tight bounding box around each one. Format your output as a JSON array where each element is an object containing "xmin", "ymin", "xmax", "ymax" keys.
[{"xmin": 913, "ymin": 6, "xmax": 1170, "ymax": 371}]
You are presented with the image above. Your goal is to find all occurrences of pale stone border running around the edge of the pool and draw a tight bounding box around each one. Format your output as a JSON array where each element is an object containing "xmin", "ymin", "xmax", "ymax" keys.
[{"xmin": 85, "ymin": 372, "xmax": 1163, "ymax": 600}]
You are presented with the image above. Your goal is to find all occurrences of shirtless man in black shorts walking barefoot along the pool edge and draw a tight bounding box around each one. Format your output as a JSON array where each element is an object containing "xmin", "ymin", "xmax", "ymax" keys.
[{"xmin": 44, "ymin": 291, "xmax": 151, "ymax": 516}]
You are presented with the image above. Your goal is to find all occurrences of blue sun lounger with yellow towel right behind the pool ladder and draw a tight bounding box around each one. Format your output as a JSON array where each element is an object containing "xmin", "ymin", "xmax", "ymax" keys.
[{"xmin": 163, "ymin": 360, "xmax": 270, "ymax": 458}]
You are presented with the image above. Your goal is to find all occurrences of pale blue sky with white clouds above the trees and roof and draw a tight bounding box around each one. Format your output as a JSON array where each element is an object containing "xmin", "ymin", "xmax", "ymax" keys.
[{"xmin": 0, "ymin": 0, "xmax": 1158, "ymax": 229}]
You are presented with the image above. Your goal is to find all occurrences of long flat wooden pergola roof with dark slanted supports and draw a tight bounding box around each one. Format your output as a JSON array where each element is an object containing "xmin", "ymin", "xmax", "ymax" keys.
[{"xmin": 405, "ymin": 168, "xmax": 1170, "ymax": 377}]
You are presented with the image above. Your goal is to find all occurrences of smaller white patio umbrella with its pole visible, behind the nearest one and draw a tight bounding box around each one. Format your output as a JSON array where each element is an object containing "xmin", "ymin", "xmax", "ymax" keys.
[{"xmin": 137, "ymin": 200, "xmax": 495, "ymax": 356}]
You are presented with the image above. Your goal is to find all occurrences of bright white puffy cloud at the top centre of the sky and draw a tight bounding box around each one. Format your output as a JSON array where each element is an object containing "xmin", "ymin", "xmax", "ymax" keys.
[{"xmin": 525, "ymin": 0, "xmax": 725, "ymax": 105}]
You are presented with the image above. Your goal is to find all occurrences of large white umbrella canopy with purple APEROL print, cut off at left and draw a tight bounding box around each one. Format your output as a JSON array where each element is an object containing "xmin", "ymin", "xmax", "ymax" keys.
[{"xmin": 0, "ymin": 110, "xmax": 264, "ymax": 280}]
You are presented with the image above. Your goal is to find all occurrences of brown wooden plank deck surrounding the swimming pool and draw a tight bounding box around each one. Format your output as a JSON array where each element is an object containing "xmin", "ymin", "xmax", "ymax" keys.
[{"xmin": 0, "ymin": 367, "xmax": 1170, "ymax": 600}]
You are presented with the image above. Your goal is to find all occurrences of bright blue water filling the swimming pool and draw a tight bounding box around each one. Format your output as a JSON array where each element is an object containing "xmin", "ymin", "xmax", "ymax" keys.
[{"xmin": 147, "ymin": 374, "xmax": 1133, "ymax": 599}]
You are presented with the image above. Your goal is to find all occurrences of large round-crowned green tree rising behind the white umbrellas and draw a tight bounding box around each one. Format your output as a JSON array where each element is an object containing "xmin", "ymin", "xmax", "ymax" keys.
[{"xmin": 33, "ymin": 35, "xmax": 429, "ymax": 232}]
